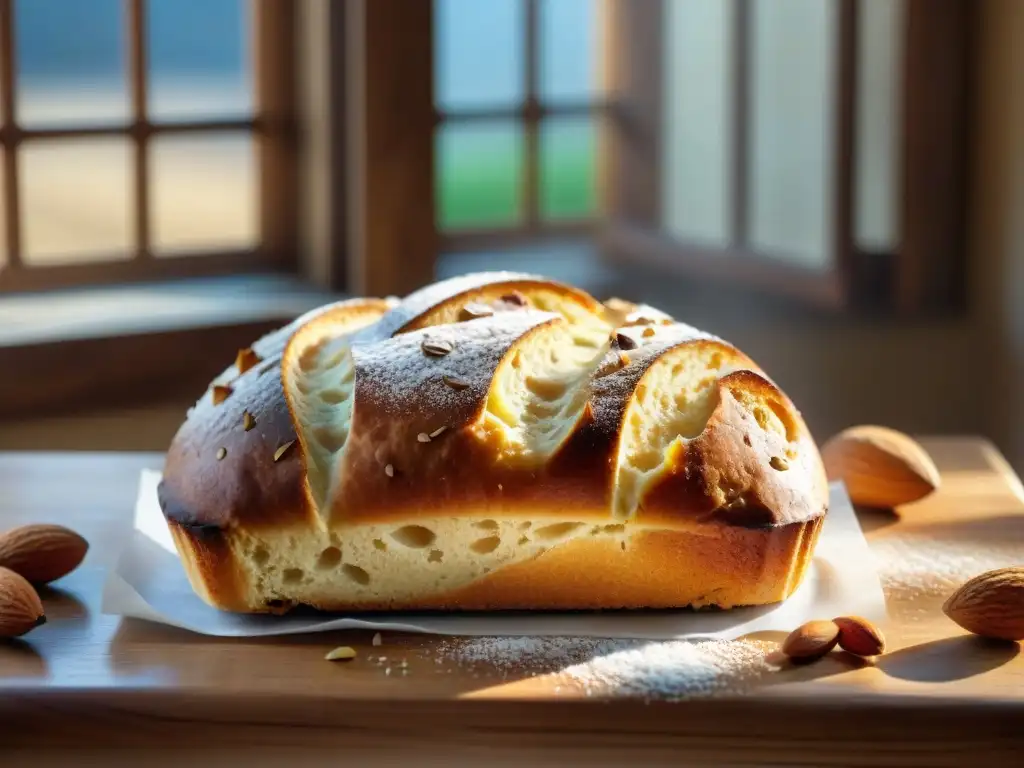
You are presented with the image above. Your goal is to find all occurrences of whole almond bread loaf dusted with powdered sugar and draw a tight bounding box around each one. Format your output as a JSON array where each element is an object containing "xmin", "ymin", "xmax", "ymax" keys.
[{"xmin": 160, "ymin": 272, "xmax": 828, "ymax": 612}]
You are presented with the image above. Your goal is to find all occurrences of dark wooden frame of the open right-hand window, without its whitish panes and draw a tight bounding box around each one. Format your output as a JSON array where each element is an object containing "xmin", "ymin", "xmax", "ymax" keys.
[{"xmin": 602, "ymin": 0, "xmax": 977, "ymax": 314}]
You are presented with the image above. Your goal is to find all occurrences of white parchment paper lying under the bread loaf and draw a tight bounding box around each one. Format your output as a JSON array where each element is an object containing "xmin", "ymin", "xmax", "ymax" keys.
[{"xmin": 102, "ymin": 470, "xmax": 885, "ymax": 640}]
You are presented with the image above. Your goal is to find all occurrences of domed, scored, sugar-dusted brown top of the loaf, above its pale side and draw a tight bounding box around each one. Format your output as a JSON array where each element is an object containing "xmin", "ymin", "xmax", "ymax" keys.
[{"xmin": 161, "ymin": 272, "xmax": 827, "ymax": 527}]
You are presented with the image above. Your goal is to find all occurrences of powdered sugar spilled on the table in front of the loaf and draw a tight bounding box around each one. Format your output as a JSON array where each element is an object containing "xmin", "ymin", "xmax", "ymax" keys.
[{"xmin": 438, "ymin": 637, "xmax": 773, "ymax": 699}]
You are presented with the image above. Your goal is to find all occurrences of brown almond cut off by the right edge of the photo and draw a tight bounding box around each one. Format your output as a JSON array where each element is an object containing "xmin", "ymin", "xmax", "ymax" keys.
[{"xmin": 942, "ymin": 565, "xmax": 1024, "ymax": 640}]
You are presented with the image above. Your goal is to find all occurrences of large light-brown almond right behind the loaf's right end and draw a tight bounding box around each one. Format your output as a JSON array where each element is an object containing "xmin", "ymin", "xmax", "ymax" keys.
[{"xmin": 821, "ymin": 426, "xmax": 940, "ymax": 508}]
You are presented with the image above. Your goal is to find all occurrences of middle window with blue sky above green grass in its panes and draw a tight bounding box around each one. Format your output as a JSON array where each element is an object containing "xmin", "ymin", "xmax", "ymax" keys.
[{"xmin": 434, "ymin": 0, "xmax": 604, "ymax": 250}]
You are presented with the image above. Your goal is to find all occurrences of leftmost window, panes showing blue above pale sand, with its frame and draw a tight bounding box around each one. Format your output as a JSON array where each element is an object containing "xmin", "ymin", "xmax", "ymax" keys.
[{"xmin": 0, "ymin": 0, "xmax": 297, "ymax": 290}]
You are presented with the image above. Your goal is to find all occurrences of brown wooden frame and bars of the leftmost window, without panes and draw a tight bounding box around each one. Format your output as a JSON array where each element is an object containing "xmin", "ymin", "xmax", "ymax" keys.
[{"xmin": 0, "ymin": 0, "xmax": 298, "ymax": 294}]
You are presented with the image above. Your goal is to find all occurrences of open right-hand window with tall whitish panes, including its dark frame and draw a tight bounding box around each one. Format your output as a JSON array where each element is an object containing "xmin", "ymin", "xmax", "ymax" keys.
[{"xmin": 607, "ymin": 0, "xmax": 973, "ymax": 311}]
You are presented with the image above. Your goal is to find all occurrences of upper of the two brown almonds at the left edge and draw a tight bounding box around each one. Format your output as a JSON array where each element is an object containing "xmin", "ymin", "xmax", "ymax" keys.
[{"xmin": 0, "ymin": 524, "xmax": 89, "ymax": 584}]
